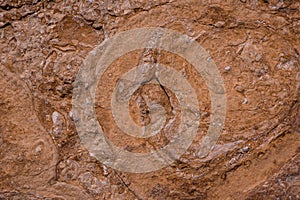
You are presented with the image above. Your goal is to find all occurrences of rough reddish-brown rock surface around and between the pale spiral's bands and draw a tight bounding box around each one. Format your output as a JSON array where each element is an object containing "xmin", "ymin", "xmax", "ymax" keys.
[{"xmin": 0, "ymin": 0, "xmax": 300, "ymax": 199}]
